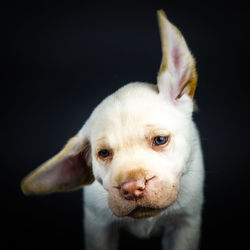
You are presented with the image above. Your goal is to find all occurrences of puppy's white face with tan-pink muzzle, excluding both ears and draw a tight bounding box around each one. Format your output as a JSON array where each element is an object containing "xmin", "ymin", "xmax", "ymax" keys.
[{"xmin": 89, "ymin": 83, "xmax": 192, "ymax": 218}]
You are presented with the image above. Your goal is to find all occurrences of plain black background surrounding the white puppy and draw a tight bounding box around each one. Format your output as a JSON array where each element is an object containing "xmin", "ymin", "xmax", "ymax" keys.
[{"xmin": 1, "ymin": 0, "xmax": 250, "ymax": 250}]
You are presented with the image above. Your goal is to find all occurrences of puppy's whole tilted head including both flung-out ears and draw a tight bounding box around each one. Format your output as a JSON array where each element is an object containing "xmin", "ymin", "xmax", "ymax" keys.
[{"xmin": 22, "ymin": 11, "xmax": 197, "ymax": 218}]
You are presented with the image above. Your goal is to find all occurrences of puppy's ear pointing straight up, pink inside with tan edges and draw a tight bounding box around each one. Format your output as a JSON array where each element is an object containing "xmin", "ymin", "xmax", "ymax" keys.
[{"xmin": 157, "ymin": 10, "xmax": 198, "ymax": 101}]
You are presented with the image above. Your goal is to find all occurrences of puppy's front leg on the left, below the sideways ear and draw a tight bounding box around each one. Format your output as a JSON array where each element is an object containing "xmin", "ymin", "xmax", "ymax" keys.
[{"xmin": 84, "ymin": 206, "xmax": 119, "ymax": 250}]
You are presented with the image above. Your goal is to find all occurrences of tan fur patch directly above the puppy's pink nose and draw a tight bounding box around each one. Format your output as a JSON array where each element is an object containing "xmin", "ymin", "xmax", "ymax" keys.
[{"xmin": 115, "ymin": 168, "xmax": 148, "ymax": 184}]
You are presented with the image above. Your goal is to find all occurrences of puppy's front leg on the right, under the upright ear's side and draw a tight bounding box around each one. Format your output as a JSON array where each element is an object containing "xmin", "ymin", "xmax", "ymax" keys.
[{"xmin": 162, "ymin": 215, "xmax": 201, "ymax": 250}]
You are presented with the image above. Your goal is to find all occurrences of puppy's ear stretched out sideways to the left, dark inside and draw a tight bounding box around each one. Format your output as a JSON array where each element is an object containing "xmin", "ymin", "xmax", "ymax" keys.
[{"xmin": 21, "ymin": 125, "xmax": 94, "ymax": 195}]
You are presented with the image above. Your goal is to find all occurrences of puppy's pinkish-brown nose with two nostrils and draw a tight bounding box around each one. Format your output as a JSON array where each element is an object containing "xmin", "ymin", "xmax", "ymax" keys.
[{"xmin": 120, "ymin": 179, "xmax": 146, "ymax": 200}]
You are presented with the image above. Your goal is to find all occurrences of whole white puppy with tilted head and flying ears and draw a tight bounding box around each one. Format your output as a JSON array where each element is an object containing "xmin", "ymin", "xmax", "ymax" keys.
[{"xmin": 21, "ymin": 10, "xmax": 204, "ymax": 250}]
